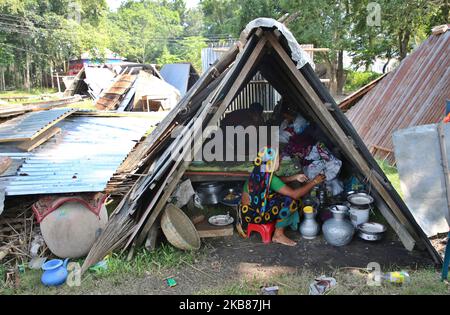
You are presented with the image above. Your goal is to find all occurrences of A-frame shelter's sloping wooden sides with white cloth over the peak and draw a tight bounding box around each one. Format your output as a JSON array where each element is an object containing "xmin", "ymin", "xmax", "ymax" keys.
[{"xmin": 82, "ymin": 18, "xmax": 442, "ymax": 271}]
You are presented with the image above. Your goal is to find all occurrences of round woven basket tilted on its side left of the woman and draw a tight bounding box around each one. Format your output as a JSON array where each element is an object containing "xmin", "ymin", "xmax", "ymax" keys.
[{"xmin": 161, "ymin": 204, "xmax": 201, "ymax": 250}]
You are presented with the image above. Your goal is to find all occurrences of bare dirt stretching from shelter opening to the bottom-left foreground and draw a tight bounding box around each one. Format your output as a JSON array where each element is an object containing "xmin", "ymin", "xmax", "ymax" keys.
[{"xmin": 81, "ymin": 233, "xmax": 433, "ymax": 294}]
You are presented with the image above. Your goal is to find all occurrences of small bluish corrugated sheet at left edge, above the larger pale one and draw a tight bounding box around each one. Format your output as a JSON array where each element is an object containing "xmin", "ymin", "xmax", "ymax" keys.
[{"xmin": 0, "ymin": 108, "xmax": 75, "ymax": 142}]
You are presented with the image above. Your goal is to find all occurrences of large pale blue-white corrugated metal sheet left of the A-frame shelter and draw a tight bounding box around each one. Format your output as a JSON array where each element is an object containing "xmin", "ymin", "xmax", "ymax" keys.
[{"xmin": 0, "ymin": 116, "xmax": 159, "ymax": 196}]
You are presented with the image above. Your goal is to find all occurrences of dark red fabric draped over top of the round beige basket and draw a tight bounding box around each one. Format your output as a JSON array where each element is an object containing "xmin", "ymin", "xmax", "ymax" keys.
[{"xmin": 32, "ymin": 193, "xmax": 108, "ymax": 223}]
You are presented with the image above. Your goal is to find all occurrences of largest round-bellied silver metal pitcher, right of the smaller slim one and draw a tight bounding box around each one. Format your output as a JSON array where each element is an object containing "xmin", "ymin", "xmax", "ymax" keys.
[{"xmin": 322, "ymin": 205, "xmax": 355, "ymax": 246}]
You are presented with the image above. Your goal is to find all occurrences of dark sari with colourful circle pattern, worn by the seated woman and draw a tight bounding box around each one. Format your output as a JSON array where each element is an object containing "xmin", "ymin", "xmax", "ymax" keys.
[{"xmin": 239, "ymin": 147, "xmax": 300, "ymax": 230}]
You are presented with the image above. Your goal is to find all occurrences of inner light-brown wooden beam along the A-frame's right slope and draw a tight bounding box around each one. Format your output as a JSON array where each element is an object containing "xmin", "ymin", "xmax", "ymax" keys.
[{"xmin": 267, "ymin": 33, "xmax": 420, "ymax": 247}]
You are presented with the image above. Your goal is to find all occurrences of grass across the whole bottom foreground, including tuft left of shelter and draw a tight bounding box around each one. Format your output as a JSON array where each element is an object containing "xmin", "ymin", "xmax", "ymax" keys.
[{"xmin": 0, "ymin": 246, "xmax": 450, "ymax": 295}]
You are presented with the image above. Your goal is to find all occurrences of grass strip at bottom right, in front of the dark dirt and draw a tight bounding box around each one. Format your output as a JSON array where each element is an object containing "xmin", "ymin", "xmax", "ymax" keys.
[{"xmin": 197, "ymin": 269, "xmax": 450, "ymax": 295}]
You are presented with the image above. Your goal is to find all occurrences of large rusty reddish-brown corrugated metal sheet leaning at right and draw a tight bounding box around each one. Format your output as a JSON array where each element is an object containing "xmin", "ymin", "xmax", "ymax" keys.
[{"xmin": 346, "ymin": 27, "xmax": 450, "ymax": 162}]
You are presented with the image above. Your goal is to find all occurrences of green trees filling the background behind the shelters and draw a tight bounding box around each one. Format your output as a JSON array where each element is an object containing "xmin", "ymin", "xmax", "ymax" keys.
[{"xmin": 0, "ymin": 0, "xmax": 449, "ymax": 88}]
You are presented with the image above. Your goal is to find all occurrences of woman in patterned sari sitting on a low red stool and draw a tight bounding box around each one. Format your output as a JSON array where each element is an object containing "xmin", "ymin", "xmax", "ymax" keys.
[{"xmin": 239, "ymin": 147, "xmax": 325, "ymax": 246}]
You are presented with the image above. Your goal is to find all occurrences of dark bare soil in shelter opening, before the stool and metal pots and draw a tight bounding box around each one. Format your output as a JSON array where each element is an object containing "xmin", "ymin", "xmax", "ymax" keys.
[{"xmin": 206, "ymin": 232, "xmax": 433, "ymax": 270}]
